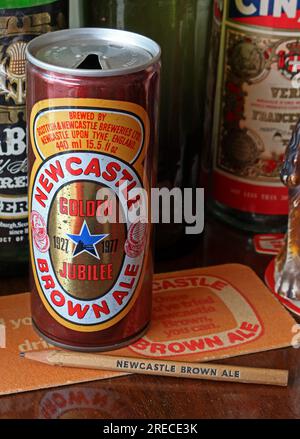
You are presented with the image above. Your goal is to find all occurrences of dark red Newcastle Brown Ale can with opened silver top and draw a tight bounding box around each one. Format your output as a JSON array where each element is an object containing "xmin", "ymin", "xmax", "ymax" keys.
[{"xmin": 27, "ymin": 28, "xmax": 160, "ymax": 351}]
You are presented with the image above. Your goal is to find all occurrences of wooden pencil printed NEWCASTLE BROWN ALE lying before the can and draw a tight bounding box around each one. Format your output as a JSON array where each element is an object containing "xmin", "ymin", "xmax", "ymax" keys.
[{"xmin": 21, "ymin": 350, "xmax": 288, "ymax": 386}]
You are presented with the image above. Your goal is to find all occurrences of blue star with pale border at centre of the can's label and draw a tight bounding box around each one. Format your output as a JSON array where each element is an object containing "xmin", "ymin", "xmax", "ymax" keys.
[{"xmin": 67, "ymin": 221, "xmax": 108, "ymax": 259}]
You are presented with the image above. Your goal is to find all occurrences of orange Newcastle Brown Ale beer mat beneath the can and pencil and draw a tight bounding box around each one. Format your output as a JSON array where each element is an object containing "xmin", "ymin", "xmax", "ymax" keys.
[{"xmin": 0, "ymin": 264, "xmax": 295, "ymax": 395}]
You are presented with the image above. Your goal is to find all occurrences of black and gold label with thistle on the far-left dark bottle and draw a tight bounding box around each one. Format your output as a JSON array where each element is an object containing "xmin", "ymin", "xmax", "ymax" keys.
[{"xmin": 0, "ymin": 1, "xmax": 67, "ymax": 250}]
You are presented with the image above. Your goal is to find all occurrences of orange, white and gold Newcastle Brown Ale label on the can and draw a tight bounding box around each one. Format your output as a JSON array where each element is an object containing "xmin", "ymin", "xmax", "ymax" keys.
[{"xmin": 29, "ymin": 98, "xmax": 150, "ymax": 332}]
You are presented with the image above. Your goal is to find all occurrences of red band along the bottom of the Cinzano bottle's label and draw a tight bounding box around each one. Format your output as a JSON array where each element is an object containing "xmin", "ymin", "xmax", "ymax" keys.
[{"xmin": 213, "ymin": 172, "xmax": 288, "ymax": 215}]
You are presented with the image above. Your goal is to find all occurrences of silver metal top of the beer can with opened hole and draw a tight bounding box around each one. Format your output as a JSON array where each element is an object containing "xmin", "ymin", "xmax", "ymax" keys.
[{"xmin": 26, "ymin": 28, "xmax": 161, "ymax": 77}]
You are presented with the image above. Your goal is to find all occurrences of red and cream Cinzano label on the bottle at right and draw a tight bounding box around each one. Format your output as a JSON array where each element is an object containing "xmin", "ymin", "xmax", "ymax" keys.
[{"xmin": 214, "ymin": 0, "xmax": 300, "ymax": 215}]
